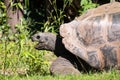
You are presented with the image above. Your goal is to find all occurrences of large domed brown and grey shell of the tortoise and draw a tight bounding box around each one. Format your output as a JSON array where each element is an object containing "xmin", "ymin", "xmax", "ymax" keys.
[{"xmin": 60, "ymin": 2, "xmax": 120, "ymax": 69}]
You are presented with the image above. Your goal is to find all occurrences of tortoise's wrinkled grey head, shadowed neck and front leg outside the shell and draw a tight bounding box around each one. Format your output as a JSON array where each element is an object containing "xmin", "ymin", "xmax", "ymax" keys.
[{"xmin": 31, "ymin": 32, "xmax": 91, "ymax": 75}]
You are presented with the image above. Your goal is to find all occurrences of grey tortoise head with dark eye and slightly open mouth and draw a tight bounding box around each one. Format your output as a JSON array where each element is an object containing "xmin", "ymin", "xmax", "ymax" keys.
[{"xmin": 31, "ymin": 32, "xmax": 56, "ymax": 51}]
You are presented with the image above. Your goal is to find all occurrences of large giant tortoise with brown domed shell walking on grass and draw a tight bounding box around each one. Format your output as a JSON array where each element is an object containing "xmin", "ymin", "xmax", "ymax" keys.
[{"xmin": 32, "ymin": 2, "xmax": 120, "ymax": 74}]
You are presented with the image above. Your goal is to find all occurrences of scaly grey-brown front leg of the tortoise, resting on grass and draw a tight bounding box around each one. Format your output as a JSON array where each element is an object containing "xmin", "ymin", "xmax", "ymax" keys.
[{"xmin": 50, "ymin": 57, "xmax": 80, "ymax": 75}]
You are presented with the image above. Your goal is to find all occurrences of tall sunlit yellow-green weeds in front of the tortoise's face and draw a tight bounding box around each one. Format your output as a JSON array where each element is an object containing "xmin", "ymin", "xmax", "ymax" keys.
[{"xmin": 0, "ymin": 19, "xmax": 49, "ymax": 75}]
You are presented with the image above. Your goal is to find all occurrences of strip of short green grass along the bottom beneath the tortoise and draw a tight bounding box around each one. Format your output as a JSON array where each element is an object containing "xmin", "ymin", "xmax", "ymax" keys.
[{"xmin": 1, "ymin": 71, "xmax": 120, "ymax": 80}]
